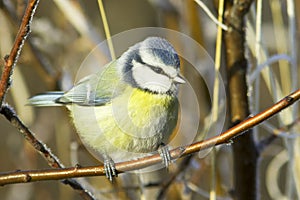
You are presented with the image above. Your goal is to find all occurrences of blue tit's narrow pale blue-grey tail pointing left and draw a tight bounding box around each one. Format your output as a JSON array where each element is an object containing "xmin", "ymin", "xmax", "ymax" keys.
[{"xmin": 28, "ymin": 91, "xmax": 64, "ymax": 106}]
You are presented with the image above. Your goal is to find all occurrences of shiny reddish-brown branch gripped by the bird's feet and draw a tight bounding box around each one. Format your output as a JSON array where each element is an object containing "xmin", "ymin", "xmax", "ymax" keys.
[{"xmin": 0, "ymin": 90, "xmax": 300, "ymax": 186}]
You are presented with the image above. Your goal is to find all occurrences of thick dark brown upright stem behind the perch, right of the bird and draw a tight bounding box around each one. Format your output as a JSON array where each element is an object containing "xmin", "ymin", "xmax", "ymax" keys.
[{"xmin": 224, "ymin": 0, "xmax": 259, "ymax": 199}]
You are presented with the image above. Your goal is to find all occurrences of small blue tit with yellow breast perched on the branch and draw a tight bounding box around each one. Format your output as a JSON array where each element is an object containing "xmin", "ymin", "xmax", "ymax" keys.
[{"xmin": 28, "ymin": 36, "xmax": 186, "ymax": 181}]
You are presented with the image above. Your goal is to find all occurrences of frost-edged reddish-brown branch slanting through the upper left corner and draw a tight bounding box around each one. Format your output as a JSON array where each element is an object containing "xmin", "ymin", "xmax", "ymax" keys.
[{"xmin": 0, "ymin": 0, "xmax": 39, "ymax": 107}]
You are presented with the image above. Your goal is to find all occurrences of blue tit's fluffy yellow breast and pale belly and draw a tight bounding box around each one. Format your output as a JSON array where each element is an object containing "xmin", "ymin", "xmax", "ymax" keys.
[{"xmin": 73, "ymin": 88, "xmax": 178, "ymax": 154}]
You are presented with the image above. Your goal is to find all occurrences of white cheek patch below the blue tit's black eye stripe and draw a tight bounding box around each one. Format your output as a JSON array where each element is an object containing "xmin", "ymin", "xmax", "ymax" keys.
[{"xmin": 132, "ymin": 63, "xmax": 172, "ymax": 92}]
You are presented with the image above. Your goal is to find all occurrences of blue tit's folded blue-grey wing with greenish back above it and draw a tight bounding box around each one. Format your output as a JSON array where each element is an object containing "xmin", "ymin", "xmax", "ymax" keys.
[{"xmin": 57, "ymin": 61, "xmax": 124, "ymax": 106}]
